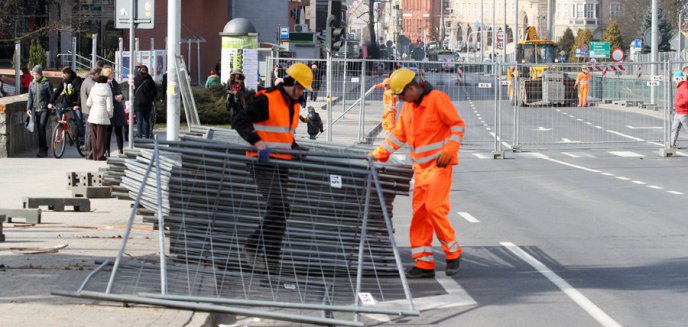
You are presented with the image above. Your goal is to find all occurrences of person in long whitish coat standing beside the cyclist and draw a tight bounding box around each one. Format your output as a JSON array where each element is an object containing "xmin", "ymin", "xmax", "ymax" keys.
[{"xmin": 86, "ymin": 76, "xmax": 114, "ymax": 160}]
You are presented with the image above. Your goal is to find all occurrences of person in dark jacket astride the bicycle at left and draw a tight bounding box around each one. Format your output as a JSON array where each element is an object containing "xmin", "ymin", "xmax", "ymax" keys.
[{"xmin": 50, "ymin": 67, "xmax": 84, "ymax": 145}]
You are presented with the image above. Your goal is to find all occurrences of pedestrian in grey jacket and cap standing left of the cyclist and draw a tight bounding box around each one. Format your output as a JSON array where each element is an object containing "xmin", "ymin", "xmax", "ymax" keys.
[{"xmin": 26, "ymin": 65, "xmax": 53, "ymax": 158}]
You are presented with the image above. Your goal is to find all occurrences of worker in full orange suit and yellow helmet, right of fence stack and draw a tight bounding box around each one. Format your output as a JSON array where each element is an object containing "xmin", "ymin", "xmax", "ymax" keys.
[{"xmin": 370, "ymin": 68, "xmax": 466, "ymax": 278}]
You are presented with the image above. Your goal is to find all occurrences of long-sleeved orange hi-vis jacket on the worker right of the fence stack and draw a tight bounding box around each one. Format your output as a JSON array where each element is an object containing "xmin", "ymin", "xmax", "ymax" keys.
[{"xmin": 373, "ymin": 90, "xmax": 466, "ymax": 168}]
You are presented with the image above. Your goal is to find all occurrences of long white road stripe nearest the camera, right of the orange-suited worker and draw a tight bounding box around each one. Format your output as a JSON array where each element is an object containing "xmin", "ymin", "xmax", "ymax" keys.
[{"xmin": 500, "ymin": 242, "xmax": 621, "ymax": 327}]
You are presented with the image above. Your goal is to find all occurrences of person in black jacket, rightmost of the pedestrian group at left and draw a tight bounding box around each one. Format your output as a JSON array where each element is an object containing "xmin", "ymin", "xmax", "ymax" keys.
[{"xmin": 134, "ymin": 65, "xmax": 158, "ymax": 139}]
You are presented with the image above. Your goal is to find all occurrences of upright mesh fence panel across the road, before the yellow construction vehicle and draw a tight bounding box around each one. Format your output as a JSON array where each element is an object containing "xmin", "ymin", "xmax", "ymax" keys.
[{"xmin": 502, "ymin": 64, "xmax": 667, "ymax": 149}]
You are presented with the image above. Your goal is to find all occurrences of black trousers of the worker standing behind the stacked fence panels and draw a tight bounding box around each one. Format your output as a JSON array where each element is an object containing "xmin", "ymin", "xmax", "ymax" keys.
[{"xmin": 246, "ymin": 162, "xmax": 289, "ymax": 264}]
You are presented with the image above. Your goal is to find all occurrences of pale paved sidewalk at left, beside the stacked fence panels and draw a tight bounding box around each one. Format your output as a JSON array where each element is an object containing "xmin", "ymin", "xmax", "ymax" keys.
[{"xmin": 0, "ymin": 156, "xmax": 209, "ymax": 327}]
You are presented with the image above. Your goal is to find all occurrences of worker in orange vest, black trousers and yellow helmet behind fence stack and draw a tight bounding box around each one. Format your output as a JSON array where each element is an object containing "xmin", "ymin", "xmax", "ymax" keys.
[{"xmin": 234, "ymin": 63, "xmax": 313, "ymax": 272}]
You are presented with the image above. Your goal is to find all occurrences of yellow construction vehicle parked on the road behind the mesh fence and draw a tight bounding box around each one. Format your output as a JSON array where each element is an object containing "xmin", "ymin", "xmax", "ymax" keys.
[{"xmin": 507, "ymin": 26, "xmax": 566, "ymax": 106}]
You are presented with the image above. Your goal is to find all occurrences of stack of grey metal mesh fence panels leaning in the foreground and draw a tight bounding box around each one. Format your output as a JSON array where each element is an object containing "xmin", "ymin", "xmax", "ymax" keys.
[{"xmin": 55, "ymin": 128, "xmax": 418, "ymax": 325}]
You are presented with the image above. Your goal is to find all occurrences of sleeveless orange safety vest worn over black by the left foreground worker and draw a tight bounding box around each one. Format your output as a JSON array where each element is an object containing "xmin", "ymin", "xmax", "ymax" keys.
[{"xmin": 246, "ymin": 89, "xmax": 301, "ymax": 160}]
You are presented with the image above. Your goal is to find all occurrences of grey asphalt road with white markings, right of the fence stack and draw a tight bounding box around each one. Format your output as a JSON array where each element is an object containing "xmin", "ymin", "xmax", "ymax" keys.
[{"xmin": 382, "ymin": 70, "xmax": 688, "ymax": 326}]
